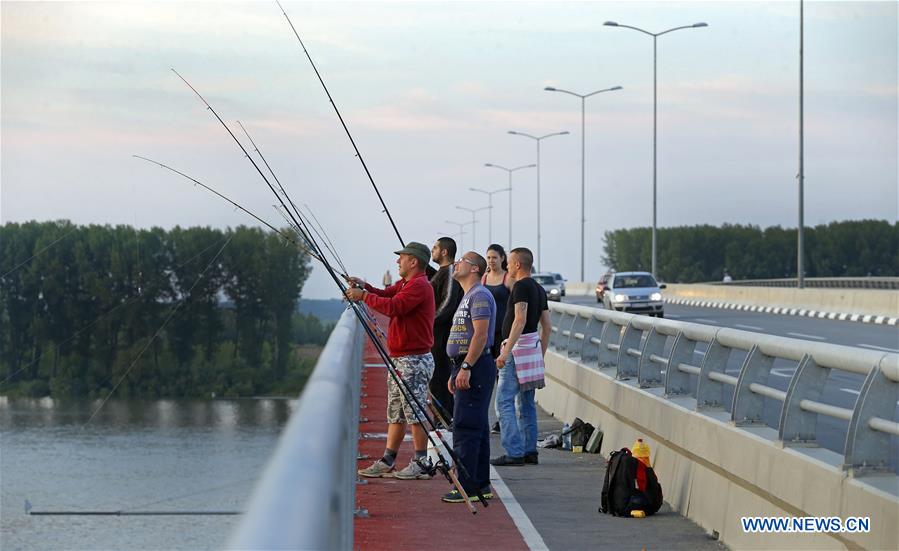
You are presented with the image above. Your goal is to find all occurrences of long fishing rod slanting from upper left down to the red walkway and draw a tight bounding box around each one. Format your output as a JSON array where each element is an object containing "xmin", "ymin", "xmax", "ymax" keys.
[{"xmin": 172, "ymin": 69, "xmax": 488, "ymax": 514}]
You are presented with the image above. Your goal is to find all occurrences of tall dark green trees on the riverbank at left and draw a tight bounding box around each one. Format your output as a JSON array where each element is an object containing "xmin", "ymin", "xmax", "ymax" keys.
[{"xmin": 0, "ymin": 221, "xmax": 330, "ymax": 397}]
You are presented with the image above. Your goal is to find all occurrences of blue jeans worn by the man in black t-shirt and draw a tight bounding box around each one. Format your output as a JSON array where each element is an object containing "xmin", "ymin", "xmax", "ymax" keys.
[{"xmin": 496, "ymin": 355, "xmax": 537, "ymax": 457}]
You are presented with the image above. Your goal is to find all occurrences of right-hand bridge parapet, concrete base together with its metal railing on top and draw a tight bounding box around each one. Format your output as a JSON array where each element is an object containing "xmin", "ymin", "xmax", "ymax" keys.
[{"xmin": 538, "ymin": 304, "xmax": 899, "ymax": 548}]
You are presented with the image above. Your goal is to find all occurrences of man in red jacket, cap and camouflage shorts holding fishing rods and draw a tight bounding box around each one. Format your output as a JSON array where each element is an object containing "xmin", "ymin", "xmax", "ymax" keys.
[{"xmin": 346, "ymin": 241, "xmax": 435, "ymax": 480}]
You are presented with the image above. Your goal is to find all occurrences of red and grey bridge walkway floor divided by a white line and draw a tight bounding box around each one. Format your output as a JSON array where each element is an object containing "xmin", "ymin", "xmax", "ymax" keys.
[{"xmin": 354, "ymin": 322, "xmax": 724, "ymax": 551}]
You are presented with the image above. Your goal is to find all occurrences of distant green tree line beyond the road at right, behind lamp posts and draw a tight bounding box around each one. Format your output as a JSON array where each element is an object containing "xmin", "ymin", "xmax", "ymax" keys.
[{"xmin": 603, "ymin": 220, "xmax": 899, "ymax": 283}]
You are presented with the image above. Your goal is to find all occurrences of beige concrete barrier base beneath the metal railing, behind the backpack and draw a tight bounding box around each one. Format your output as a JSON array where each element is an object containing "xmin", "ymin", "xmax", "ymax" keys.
[{"xmin": 537, "ymin": 350, "xmax": 899, "ymax": 549}]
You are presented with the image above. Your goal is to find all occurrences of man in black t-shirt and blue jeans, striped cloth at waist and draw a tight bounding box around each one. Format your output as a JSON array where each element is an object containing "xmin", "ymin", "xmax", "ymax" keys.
[{"xmin": 490, "ymin": 247, "xmax": 551, "ymax": 466}]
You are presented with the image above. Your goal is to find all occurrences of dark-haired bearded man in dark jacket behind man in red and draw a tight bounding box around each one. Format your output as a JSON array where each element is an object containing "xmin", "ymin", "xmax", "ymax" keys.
[{"xmin": 429, "ymin": 237, "xmax": 464, "ymax": 424}]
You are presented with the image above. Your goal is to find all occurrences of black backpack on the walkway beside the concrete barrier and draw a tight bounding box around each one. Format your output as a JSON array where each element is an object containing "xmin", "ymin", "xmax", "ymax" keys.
[{"xmin": 599, "ymin": 448, "xmax": 662, "ymax": 517}]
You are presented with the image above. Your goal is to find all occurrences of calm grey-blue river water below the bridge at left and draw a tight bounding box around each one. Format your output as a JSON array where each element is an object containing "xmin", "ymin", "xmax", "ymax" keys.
[{"xmin": 0, "ymin": 397, "xmax": 295, "ymax": 551}]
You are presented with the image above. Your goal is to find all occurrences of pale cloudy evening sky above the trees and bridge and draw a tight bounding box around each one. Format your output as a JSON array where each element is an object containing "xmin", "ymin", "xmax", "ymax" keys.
[{"xmin": 0, "ymin": 1, "xmax": 899, "ymax": 298}]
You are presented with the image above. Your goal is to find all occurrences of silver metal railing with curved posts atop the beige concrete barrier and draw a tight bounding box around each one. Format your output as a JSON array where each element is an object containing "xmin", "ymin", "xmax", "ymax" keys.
[{"xmin": 550, "ymin": 304, "xmax": 899, "ymax": 476}]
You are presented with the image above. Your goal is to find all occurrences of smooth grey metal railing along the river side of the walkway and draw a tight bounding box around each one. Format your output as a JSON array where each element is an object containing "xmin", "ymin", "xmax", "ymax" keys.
[{"xmin": 228, "ymin": 310, "xmax": 364, "ymax": 549}]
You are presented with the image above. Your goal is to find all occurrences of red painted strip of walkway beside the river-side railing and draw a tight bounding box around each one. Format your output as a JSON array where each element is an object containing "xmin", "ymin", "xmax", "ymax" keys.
[{"xmin": 354, "ymin": 319, "xmax": 528, "ymax": 551}]
